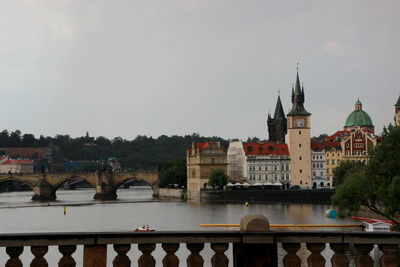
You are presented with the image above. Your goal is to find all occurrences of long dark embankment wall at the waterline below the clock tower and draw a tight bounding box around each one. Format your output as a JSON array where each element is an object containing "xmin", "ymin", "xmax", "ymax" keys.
[{"xmin": 200, "ymin": 189, "xmax": 335, "ymax": 205}]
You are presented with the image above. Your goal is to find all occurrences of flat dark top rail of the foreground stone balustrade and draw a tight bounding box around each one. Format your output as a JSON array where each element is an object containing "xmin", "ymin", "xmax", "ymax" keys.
[{"xmin": 0, "ymin": 230, "xmax": 400, "ymax": 247}]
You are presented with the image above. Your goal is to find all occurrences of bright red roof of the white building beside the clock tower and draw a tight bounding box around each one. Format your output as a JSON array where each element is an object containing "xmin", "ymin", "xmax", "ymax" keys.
[{"xmin": 243, "ymin": 142, "xmax": 289, "ymax": 156}]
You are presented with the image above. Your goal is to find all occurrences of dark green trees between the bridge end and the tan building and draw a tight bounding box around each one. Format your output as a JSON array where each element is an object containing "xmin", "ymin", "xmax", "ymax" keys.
[{"xmin": 160, "ymin": 158, "xmax": 187, "ymax": 187}]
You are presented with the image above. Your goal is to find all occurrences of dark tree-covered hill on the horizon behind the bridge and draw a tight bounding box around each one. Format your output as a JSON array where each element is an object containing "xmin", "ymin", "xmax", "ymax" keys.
[{"xmin": 0, "ymin": 130, "xmax": 229, "ymax": 169}]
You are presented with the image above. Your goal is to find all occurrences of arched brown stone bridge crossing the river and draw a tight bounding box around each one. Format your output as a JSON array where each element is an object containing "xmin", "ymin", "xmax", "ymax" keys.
[{"xmin": 0, "ymin": 171, "xmax": 160, "ymax": 201}]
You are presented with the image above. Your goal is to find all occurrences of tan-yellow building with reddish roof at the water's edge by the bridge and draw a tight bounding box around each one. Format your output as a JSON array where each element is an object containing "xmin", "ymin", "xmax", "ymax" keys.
[{"xmin": 186, "ymin": 142, "xmax": 228, "ymax": 200}]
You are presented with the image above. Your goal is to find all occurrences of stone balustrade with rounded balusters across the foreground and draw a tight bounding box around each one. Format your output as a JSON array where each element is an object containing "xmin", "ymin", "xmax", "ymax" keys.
[{"xmin": 0, "ymin": 216, "xmax": 400, "ymax": 267}]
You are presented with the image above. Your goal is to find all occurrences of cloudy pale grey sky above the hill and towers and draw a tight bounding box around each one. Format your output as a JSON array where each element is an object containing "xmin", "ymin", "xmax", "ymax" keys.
[{"xmin": 0, "ymin": 0, "xmax": 400, "ymax": 139}]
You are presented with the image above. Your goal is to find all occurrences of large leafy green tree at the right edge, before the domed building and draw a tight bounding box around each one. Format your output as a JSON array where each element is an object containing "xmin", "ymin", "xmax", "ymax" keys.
[{"xmin": 332, "ymin": 125, "xmax": 400, "ymax": 229}]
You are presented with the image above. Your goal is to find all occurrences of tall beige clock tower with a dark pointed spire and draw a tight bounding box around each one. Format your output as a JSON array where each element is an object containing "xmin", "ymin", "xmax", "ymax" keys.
[{"xmin": 287, "ymin": 71, "xmax": 312, "ymax": 188}]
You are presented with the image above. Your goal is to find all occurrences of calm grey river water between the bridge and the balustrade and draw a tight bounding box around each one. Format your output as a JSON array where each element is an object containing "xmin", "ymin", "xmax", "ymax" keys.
[{"xmin": 0, "ymin": 187, "xmax": 354, "ymax": 266}]
